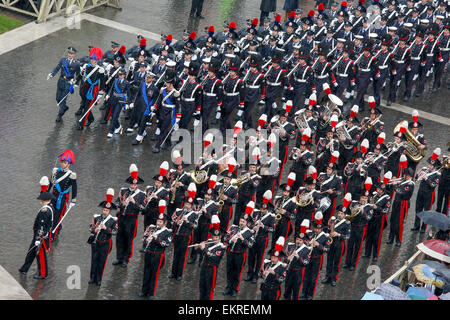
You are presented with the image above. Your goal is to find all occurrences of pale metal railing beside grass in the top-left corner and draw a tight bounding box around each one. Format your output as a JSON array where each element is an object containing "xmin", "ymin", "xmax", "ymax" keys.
[{"xmin": 0, "ymin": 0, "xmax": 121, "ymax": 23}]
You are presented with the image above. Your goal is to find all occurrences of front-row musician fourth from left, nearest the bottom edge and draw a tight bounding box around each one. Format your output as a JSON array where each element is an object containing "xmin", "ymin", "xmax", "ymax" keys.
[{"xmin": 259, "ymin": 237, "xmax": 287, "ymax": 300}]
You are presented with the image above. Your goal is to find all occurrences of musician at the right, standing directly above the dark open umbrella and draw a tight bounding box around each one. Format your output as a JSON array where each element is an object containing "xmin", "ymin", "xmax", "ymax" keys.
[{"xmin": 411, "ymin": 150, "xmax": 442, "ymax": 233}]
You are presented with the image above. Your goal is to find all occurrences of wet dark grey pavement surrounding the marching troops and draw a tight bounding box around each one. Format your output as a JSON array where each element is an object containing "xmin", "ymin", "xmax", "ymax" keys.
[{"xmin": 0, "ymin": 0, "xmax": 450, "ymax": 300}]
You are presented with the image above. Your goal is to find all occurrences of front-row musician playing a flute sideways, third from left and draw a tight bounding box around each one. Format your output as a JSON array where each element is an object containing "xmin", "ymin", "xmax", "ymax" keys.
[{"xmin": 199, "ymin": 220, "xmax": 226, "ymax": 300}]
